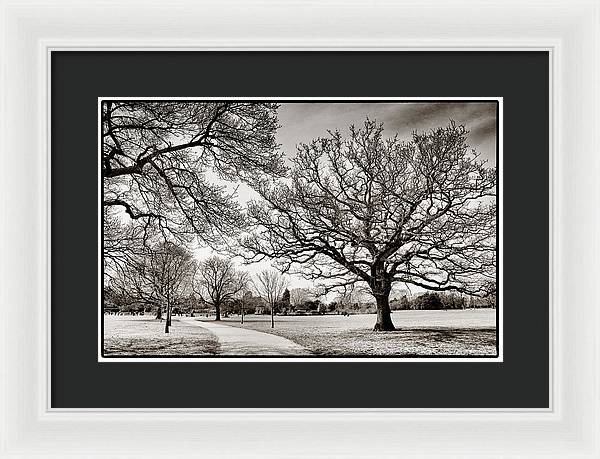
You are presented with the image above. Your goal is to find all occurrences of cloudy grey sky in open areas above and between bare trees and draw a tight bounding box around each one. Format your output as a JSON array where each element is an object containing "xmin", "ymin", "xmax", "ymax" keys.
[{"xmin": 197, "ymin": 101, "xmax": 497, "ymax": 296}]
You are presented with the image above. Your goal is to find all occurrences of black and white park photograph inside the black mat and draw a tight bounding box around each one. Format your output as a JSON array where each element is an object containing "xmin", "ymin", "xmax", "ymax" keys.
[{"xmin": 98, "ymin": 97, "xmax": 502, "ymax": 361}]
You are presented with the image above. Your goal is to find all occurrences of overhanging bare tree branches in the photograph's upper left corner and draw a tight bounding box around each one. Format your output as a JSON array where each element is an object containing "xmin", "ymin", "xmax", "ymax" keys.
[{"xmin": 102, "ymin": 100, "xmax": 284, "ymax": 252}]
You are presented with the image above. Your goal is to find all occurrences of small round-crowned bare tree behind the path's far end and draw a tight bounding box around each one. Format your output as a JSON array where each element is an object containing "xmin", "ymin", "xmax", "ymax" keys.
[{"xmin": 194, "ymin": 255, "xmax": 248, "ymax": 320}]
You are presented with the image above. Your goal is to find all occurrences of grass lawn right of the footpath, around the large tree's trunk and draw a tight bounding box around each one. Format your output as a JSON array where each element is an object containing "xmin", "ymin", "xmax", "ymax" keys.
[{"xmin": 222, "ymin": 309, "xmax": 496, "ymax": 356}]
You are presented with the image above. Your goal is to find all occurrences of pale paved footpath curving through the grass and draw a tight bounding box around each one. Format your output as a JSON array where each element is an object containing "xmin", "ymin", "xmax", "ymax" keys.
[{"xmin": 180, "ymin": 318, "xmax": 310, "ymax": 356}]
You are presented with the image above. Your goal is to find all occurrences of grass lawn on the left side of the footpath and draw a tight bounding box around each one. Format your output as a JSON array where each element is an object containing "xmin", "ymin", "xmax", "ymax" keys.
[{"xmin": 104, "ymin": 315, "xmax": 219, "ymax": 356}]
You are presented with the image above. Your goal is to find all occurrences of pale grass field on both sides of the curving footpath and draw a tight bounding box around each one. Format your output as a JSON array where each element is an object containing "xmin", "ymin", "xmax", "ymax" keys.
[{"xmin": 104, "ymin": 309, "xmax": 496, "ymax": 356}]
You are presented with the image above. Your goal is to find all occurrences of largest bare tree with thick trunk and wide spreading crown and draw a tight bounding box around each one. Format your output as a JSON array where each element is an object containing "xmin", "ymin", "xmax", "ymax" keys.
[{"xmin": 241, "ymin": 120, "xmax": 496, "ymax": 330}]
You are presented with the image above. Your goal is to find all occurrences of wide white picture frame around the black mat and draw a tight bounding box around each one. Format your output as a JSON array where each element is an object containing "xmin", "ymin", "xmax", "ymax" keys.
[{"xmin": 0, "ymin": 0, "xmax": 600, "ymax": 458}]
